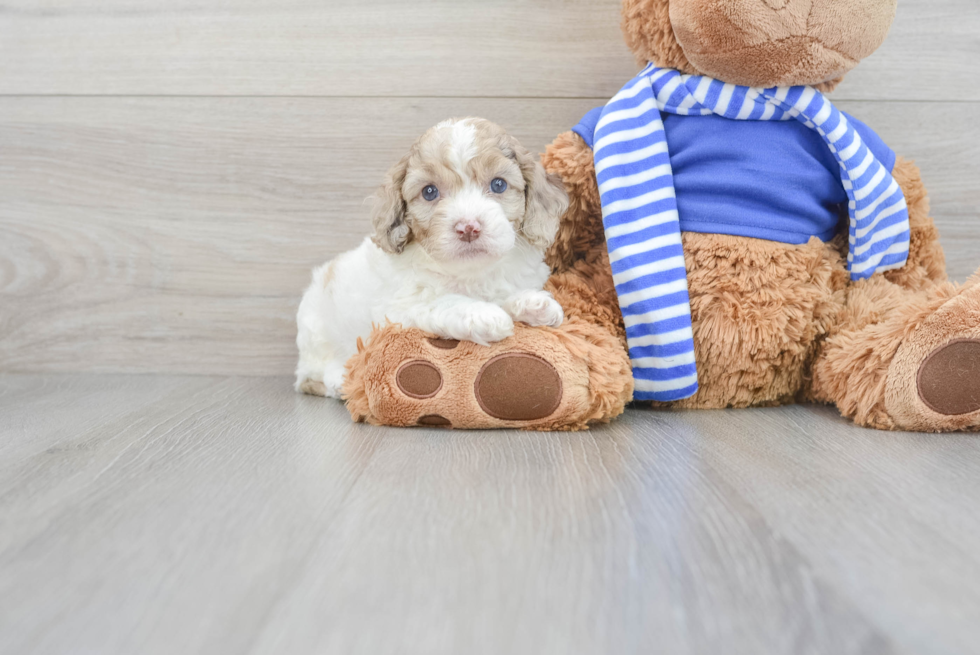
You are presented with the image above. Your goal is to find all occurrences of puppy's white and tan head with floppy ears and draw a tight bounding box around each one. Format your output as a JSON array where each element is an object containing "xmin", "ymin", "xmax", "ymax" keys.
[{"xmin": 372, "ymin": 118, "xmax": 568, "ymax": 268}]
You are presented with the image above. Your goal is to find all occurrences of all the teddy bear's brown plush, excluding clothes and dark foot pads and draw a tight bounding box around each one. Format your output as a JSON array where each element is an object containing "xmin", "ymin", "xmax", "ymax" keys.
[{"xmin": 334, "ymin": 0, "xmax": 980, "ymax": 431}]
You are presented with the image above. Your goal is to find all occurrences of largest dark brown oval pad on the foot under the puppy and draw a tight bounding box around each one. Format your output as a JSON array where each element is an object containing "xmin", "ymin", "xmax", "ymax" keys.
[{"xmin": 474, "ymin": 353, "xmax": 562, "ymax": 421}]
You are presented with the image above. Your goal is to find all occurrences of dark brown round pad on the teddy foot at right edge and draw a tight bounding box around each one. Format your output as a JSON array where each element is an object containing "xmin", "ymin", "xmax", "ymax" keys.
[{"xmin": 917, "ymin": 339, "xmax": 980, "ymax": 416}]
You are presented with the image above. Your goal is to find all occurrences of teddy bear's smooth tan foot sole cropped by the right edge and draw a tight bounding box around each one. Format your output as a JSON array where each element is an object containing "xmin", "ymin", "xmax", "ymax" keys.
[{"xmin": 885, "ymin": 284, "xmax": 980, "ymax": 432}]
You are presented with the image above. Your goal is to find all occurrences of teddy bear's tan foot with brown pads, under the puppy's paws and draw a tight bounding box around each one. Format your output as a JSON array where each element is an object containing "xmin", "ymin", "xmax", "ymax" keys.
[{"xmin": 345, "ymin": 324, "xmax": 608, "ymax": 430}]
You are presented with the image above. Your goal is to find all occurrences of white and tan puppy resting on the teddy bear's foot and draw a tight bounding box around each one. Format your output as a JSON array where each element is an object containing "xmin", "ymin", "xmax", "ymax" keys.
[{"xmin": 296, "ymin": 118, "xmax": 568, "ymax": 398}]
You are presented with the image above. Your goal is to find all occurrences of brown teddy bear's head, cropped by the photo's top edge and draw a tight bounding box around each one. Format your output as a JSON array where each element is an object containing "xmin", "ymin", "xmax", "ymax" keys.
[{"xmin": 623, "ymin": 0, "xmax": 897, "ymax": 90}]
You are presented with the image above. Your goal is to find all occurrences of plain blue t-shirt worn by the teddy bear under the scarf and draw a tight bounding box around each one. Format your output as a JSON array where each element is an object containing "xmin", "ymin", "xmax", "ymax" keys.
[{"xmin": 573, "ymin": 107, "xmax": 895, "ymax": 244}]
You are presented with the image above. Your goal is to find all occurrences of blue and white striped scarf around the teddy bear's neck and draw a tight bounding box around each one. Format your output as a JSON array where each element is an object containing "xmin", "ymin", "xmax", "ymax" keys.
[{"xmin": 593, "ymin": 64, "xmax": 909, "ymax": 402}]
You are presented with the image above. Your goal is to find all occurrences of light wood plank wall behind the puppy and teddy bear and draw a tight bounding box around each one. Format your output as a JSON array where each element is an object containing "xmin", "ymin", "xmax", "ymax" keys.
[{"xmin": 0, "ymin": 0, "xmax": 980, "ymax": 375}]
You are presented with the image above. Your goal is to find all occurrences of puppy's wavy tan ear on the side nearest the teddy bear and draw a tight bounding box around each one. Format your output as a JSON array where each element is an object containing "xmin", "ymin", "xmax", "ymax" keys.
[{"xmin": 512, "ymin": 143, "xmax": 568, "ymax": 250}]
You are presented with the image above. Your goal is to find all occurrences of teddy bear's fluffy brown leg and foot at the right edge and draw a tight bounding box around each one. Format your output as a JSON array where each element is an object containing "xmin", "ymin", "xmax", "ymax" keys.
[{"xmin": 811, "ymin": 276, "xmax": 980, "ymax": 432}]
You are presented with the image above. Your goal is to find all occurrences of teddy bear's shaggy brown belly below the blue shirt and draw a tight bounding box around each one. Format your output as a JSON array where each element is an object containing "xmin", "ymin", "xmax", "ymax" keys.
[{"xmin": 660, "ymin": 233, "xmax": 846, "ymax": 408}]
